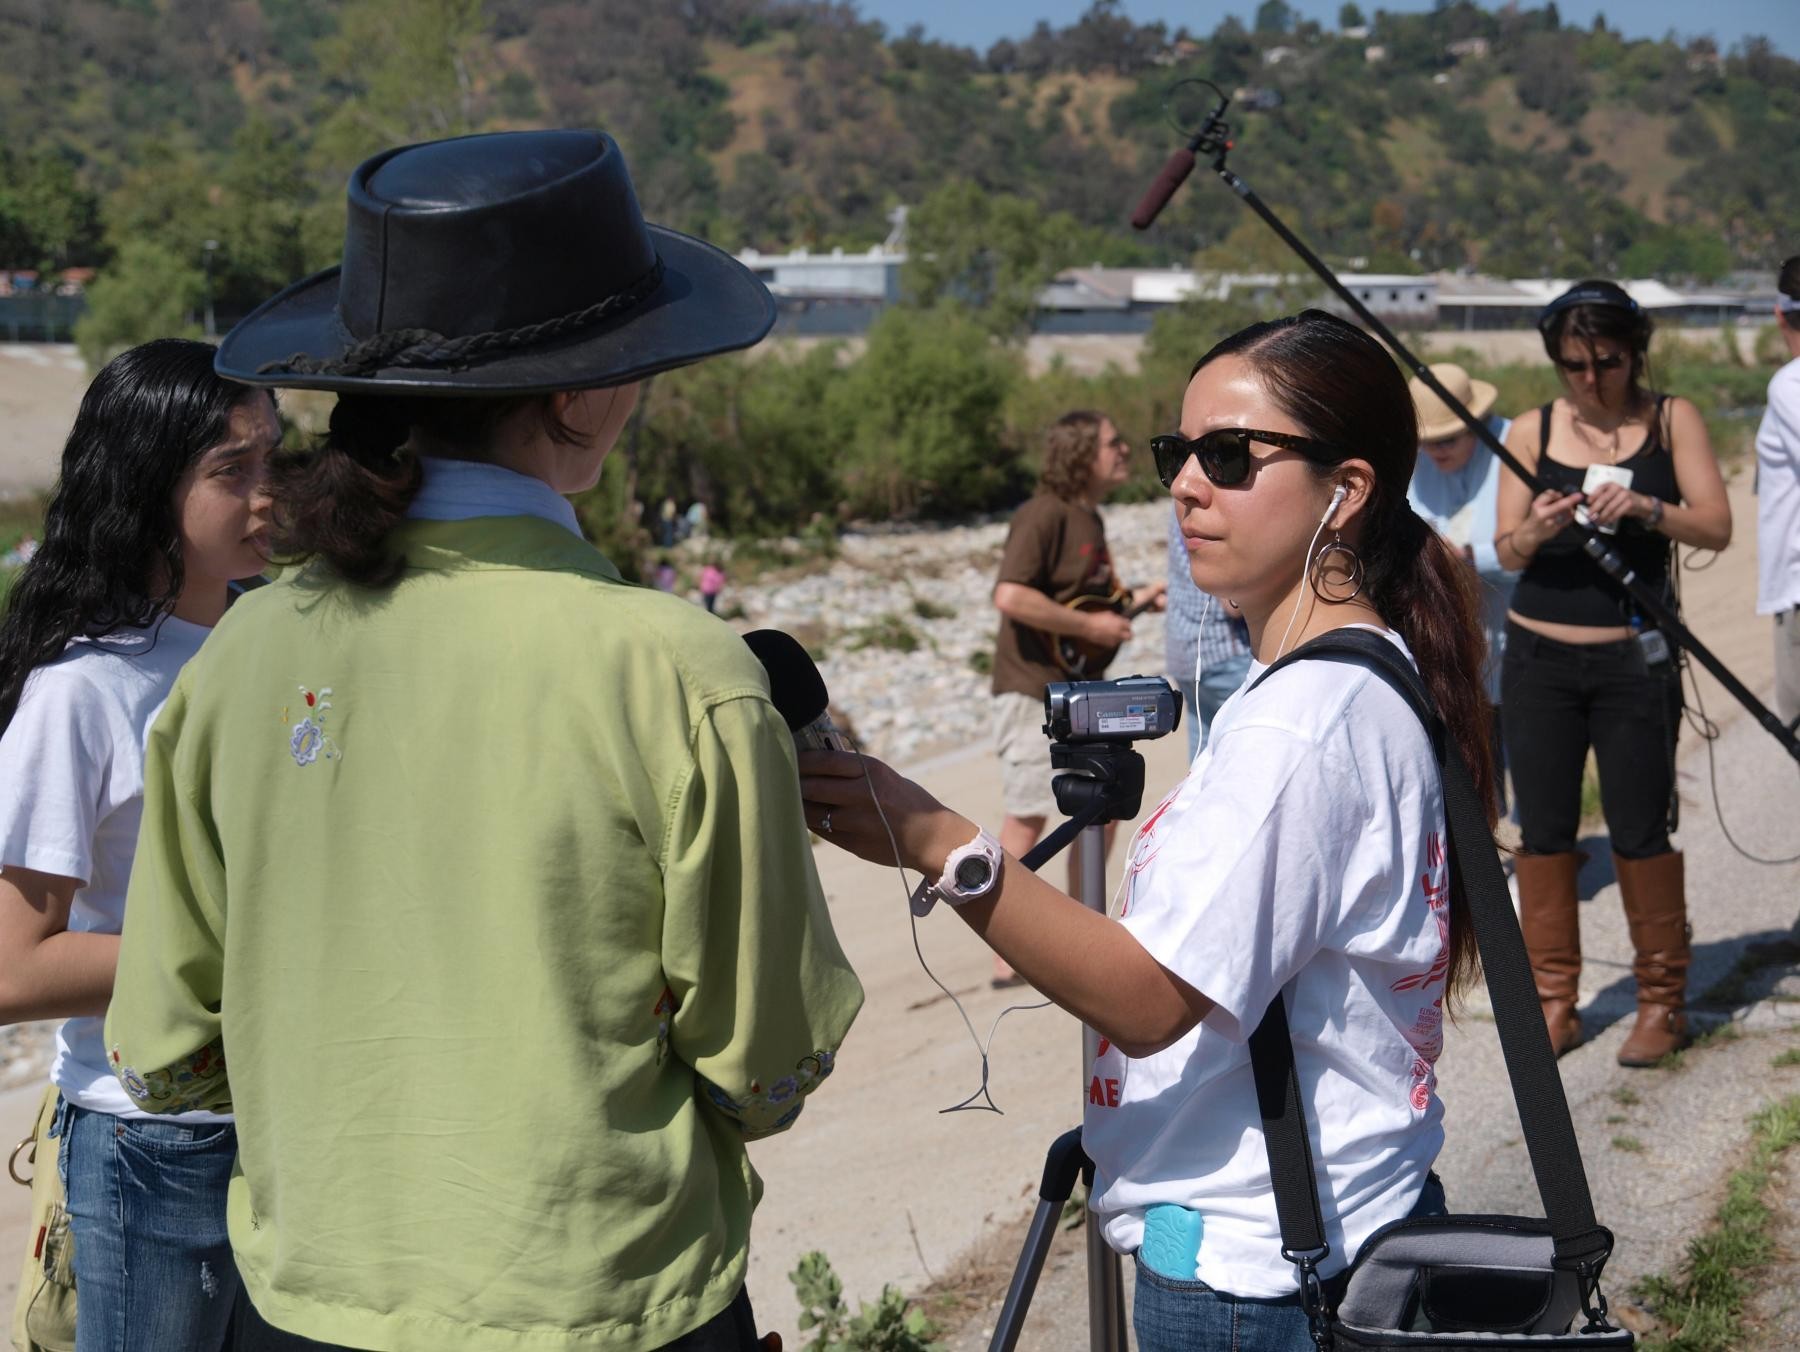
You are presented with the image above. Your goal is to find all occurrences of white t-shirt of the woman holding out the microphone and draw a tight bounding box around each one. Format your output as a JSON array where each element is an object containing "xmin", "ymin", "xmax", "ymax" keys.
[{"xmin": 1084, "ymin": 632, "xmax": 1449, "ymax": 1296}]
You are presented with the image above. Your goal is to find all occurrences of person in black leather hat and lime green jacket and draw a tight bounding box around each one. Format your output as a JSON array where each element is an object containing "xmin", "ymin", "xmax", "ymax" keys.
[{"xmin": 106, "ymin": 130, "xmax": 862, "ymax": 1352}]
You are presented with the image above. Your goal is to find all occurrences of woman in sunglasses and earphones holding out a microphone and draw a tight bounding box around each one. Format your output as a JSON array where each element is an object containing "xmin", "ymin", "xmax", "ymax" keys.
[{"xmin": 801, "ymin": 310, "xmax": 1490, "ymax": 1350}]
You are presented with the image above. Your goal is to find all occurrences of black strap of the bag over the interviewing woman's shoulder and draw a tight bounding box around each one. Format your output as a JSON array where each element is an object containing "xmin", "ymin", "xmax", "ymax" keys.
[{"xmin": 1249, "ymin": 628, "xmax": 1613, "ymax": 1275}]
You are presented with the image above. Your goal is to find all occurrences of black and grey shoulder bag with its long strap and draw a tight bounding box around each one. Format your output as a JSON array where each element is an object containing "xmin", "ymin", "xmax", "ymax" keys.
[{"xmin": 1249, "ymin": 628, "xmax": 1633, "ymax": 1352}]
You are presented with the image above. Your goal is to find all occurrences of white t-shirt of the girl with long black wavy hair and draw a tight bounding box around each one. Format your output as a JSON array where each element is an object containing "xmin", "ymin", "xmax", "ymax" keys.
[{"xmin": 0, "ymin": 616, "xmax": 230, "ymax": 1122}]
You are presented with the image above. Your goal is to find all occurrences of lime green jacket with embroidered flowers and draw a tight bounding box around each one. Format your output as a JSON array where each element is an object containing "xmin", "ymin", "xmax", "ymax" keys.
[{"xmin": 106, "ymin": 517, "xmax": 862, "ymax": 1352}]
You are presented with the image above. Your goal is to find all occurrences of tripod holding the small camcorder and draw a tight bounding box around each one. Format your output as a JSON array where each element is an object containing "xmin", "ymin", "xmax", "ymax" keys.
[{"xmin": 988, "ymin": 742, "xmax": 1143, "ymax": 1352}]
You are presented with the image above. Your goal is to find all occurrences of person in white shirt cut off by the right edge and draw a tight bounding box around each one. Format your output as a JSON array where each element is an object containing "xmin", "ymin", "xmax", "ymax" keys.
[{"xmin": 1757, "ymin": 254, "xmax": 1800, "ymax": 727}]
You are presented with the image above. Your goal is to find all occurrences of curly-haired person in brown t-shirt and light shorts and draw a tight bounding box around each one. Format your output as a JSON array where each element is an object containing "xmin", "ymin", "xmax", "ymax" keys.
[{"xmin": 994, "ymin": 409, "xmax": 1168, "ymax": 985}]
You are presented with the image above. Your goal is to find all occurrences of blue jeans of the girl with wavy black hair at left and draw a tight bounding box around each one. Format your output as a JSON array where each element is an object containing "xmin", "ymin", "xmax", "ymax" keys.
[{"xmin": 50, "ymin": 1100, "xmax": 239, "ymax": 1352}]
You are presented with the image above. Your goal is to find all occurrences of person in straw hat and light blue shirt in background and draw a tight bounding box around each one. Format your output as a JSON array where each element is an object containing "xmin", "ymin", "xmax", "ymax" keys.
[{"xmin": 1406, "ymin": 362, "xmax": 1519, "ymax": 810}]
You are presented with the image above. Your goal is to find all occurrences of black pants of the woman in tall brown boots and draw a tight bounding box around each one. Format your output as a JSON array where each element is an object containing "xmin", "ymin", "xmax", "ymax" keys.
[{"xmin": 1499, "ymin": 625, "xmax": 1681, "ymax": 859}]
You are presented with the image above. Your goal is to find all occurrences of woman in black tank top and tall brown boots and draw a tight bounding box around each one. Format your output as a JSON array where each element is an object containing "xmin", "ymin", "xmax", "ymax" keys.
[{"xmin": 1494, "ymin": 281, "xmax": 1732, "ymax": 1066}]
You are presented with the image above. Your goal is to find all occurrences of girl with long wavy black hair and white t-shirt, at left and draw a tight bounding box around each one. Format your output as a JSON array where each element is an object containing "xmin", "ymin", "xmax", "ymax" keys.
[{"xmin": 0, "ymin": 338, "xmax": 281, "ymax": 1352}]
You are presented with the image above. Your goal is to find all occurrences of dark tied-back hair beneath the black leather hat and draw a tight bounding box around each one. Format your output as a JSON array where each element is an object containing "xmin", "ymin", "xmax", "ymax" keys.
[{"xmin": 268, "ymin": 394, "xmax": 581, "ymax": 589}]
